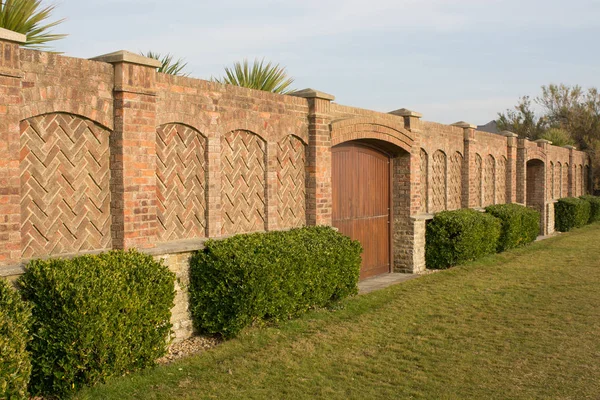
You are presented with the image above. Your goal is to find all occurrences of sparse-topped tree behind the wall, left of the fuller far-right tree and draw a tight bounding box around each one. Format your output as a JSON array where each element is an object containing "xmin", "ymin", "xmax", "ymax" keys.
[{"xmin": 496, "ymin": 96, "xmax": 547, "ymax": 140}]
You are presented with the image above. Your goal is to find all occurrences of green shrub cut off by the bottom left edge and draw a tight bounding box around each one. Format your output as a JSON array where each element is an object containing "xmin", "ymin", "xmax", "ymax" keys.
[{"xmin": 0, "ymin": 279, "xmax": 31, "ymax": 399}]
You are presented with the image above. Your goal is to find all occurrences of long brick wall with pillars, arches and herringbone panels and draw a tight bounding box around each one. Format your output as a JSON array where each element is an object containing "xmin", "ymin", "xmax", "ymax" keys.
[{"xmin": 0, "ymin": 35, "xmax": 591, "ymax": 337}]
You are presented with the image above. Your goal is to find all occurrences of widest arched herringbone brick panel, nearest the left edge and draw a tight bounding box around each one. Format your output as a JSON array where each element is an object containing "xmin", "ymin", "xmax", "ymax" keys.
[{"xmin": 21, "ymin": 113, "xmax": 111, "ymax": 258}]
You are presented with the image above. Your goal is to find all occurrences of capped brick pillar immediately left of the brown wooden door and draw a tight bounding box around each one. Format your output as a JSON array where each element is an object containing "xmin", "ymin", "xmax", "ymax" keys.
[{"xmin": 292, "ymin": 89, "xmax": 335, "ymax": 225}]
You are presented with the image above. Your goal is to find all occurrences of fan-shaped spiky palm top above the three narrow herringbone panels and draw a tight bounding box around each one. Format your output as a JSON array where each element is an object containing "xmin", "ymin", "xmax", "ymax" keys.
[{"xmin": 213, "ymin": 59, "xmax": 294, "ymax": 94}]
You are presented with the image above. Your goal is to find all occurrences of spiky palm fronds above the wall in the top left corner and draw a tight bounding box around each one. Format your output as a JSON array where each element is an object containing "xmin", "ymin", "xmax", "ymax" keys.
[{"xmin": 0, "ymin": 0, "xmax": 67, "ymax": 50}]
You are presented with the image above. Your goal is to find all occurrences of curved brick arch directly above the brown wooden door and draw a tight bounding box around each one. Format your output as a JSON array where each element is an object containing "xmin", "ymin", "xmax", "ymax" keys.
[{"xmin": 331, "ymin": 118, "xmax": 414, "ymax": 152}]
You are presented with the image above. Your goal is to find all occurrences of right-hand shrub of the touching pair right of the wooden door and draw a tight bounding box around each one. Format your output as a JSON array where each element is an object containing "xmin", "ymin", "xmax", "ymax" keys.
[{"xmin": 485, "ymin": 204, "xmax": 540, "ymax": 252}]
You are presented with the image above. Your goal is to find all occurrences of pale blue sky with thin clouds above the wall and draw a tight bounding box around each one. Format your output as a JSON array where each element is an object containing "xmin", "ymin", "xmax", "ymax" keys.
[{"xmin": 50, "ymin": 0, "xmax": 600, "ymax": 124}]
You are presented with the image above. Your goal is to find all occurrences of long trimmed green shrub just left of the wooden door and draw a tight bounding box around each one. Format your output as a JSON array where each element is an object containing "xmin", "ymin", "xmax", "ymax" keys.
[{"xmin": 189, "ymin": 227, "xmax": 362, "ymax": 337}]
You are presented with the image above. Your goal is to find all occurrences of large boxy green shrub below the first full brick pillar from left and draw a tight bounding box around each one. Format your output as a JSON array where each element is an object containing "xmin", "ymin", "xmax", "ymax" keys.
[{"xmin": 19, "ymin": 251, "xmax": 175, "ymax": 397}]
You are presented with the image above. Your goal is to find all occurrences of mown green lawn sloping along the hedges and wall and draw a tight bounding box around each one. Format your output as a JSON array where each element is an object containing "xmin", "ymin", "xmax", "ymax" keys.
[{"xmin": 78, "ymin": 224, "xmax": 600, "ymax": 400}]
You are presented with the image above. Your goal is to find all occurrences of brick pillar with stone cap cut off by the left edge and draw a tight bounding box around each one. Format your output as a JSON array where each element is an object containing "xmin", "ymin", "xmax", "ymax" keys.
[{"xmin": 0, "ymin": 28, "xmax": 27, "ymax": 266}]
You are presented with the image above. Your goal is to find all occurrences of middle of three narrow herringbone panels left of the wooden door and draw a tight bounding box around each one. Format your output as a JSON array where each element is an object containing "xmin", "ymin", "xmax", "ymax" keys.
[{"xmin": 221, "ymin": 130, "xmax": 266, "ymax": 235}]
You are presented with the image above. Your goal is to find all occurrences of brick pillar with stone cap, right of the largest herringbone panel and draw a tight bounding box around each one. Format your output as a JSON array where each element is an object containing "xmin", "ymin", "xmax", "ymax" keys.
[{"xmin": 93, "ymin": 51, "xmax": 161, "ymax": 248}]
